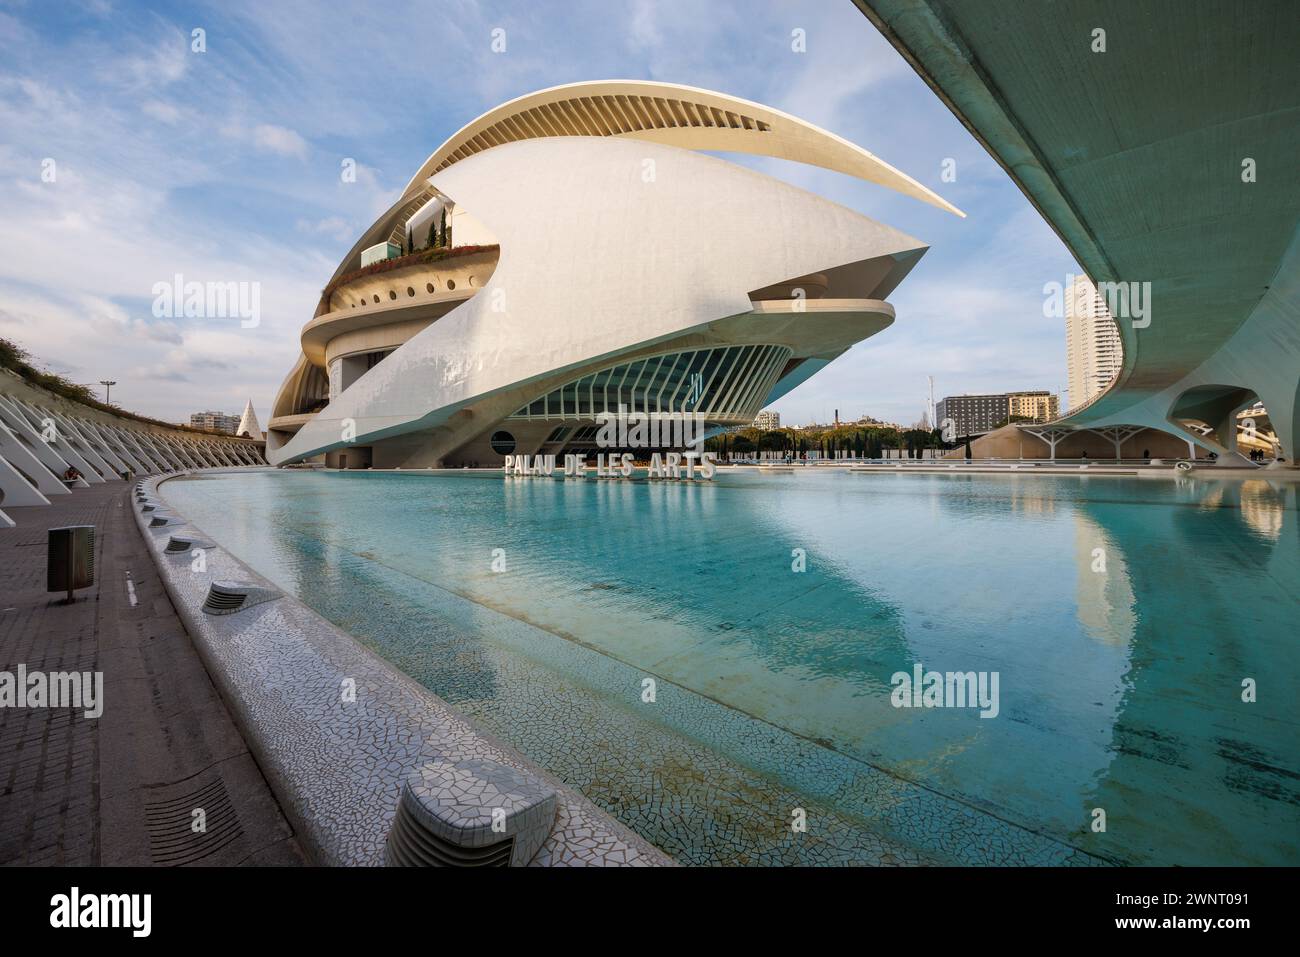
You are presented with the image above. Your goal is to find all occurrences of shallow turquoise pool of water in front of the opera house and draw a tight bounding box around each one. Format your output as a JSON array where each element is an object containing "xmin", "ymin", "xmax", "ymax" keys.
[{"xmin": 163, "ymin": 469, "xmax": 1300, "ymax": 865}]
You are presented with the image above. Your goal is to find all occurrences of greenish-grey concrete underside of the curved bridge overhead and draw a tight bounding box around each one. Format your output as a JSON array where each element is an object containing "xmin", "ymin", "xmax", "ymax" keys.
[{"xmin": 855, "ymin": 0, "xmax": 1300, "ymax": 459}]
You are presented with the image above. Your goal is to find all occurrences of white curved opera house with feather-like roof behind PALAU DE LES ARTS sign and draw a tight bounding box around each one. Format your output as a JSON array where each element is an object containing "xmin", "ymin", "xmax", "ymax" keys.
[{"xmin": 267, "ymin": 81, "xmax": 961, "ymax": 468}]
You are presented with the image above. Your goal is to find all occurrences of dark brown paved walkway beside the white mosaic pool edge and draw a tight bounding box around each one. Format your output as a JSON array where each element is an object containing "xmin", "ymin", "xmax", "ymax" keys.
[{"xmin": 0, "ymin": 481, "xmax": 306, "ymax": 865}]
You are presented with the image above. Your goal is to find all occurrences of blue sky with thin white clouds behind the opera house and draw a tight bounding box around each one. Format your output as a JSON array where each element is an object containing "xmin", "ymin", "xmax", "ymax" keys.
[{"xmin": 0, "ymin": 0, "xmax": 1076, "ymax": 424}]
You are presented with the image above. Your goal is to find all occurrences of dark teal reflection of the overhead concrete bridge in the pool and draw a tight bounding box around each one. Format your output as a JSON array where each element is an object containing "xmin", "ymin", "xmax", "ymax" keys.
[{"xmin": 1080, "ymin": 479, "xmax": 1300, "ymax": 865}]
